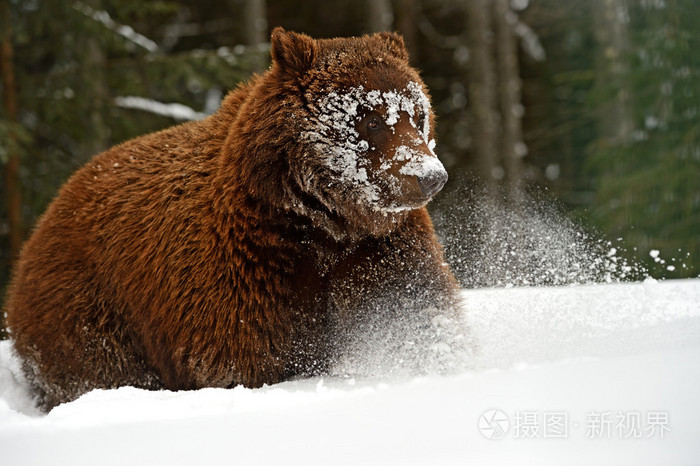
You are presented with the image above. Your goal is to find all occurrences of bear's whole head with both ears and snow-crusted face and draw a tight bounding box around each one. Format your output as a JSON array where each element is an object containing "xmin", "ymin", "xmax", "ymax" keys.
[{"xmin": 270, "ymin": 28, "xmax": 447, "ymax": 239}]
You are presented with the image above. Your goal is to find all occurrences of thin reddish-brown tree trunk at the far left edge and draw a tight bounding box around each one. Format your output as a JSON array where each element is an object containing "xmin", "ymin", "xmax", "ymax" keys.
[{"xmin": 0, "ymin": 0, "xmax": 24, "ymax": 261}]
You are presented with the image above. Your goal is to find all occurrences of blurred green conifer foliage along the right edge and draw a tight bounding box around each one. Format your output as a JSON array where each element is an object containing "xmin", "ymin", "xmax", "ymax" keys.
[{"xmin": 587, "ymin": 0, "xmax": 700, "ymax": 277}]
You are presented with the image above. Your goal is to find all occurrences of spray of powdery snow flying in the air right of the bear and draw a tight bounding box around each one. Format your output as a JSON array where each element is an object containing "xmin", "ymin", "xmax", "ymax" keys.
[{"xmin": 433, "ymin": 185, "xmax": 649, "ymax": 288}]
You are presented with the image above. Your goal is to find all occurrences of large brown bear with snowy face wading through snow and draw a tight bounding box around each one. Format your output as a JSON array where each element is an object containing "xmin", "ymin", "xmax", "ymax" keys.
[{"xmin": 7, "ymin": 28, "xmax": 457, "ymax": 409}]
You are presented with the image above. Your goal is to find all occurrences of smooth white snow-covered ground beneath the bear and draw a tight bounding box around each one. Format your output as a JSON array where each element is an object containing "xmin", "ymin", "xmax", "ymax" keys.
[{"xmin": 0, "ymin": 280, "xmax": 700, "ymax": 465}]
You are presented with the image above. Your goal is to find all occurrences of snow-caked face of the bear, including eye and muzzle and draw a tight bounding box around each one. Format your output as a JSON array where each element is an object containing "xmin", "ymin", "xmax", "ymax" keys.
[{"xmin": 302, "ymin": 81, "xmax": 447, "ymax": 216}]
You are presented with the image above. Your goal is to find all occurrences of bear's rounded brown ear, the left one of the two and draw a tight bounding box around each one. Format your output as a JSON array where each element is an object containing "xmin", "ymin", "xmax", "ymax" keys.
[{"xmin": 270, "ymin": 27, "xmax": 316, "ymax": 76}]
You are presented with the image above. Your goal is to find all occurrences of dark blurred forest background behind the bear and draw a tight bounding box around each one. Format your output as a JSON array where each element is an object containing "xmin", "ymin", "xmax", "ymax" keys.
[{"xmin": 0, "ymin": 0, "xmax": 700, "ymax": 320}]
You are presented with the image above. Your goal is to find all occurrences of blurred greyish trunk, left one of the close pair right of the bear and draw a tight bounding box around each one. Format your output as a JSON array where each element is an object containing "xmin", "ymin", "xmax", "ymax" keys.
[{"xmin": 466, "ymin": 0, "xmax": 502, "ymax": 192}]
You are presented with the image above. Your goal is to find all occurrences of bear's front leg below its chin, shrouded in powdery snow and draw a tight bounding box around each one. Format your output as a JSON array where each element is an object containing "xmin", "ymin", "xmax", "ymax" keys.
[{"xmin": 330, "ymin": 209, "xmax": 466, "ymax": 375}]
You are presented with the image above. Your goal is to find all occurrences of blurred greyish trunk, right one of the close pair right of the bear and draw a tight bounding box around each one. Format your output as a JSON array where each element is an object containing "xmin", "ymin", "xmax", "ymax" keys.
[{"xmin": 494, "ymin": 0, "xmax": 526, "ymax": 200}]
